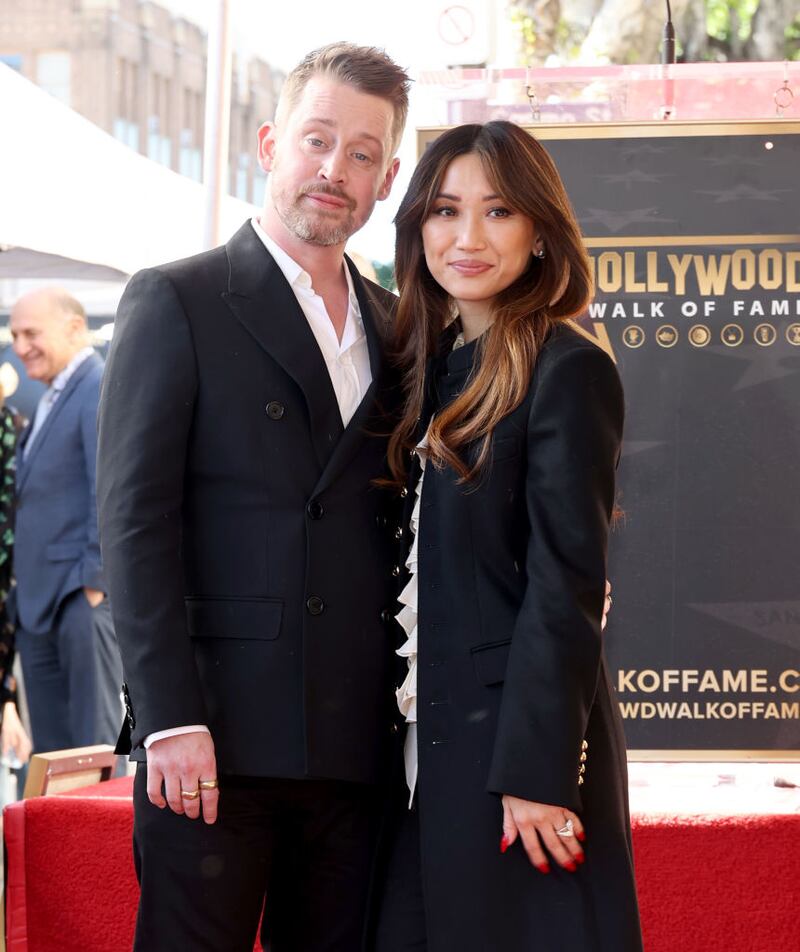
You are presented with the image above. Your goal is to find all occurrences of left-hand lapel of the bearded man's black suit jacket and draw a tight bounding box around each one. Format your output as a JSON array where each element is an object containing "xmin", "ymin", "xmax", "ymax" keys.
[{"xmin": 222, "ymin": 222, "xmax": 343, "ymax": 470}]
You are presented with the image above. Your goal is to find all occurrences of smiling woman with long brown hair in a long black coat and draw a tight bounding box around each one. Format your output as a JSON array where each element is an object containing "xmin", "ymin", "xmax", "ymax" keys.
[{"xmin": 376, "ymin": 122, "xmax": 642, "ymax": 952}]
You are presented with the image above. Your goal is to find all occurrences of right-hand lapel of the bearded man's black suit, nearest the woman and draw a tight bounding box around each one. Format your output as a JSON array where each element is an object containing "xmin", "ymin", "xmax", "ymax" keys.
[{"xmin": 317, "ymin": 258, "xmax": 392, "ymax": 492}]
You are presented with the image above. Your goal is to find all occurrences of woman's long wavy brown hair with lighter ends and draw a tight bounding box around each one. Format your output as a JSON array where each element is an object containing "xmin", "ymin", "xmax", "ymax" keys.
[{"xmin": 388, "ymin": 122, "xmax": 592, "ymax": 485}]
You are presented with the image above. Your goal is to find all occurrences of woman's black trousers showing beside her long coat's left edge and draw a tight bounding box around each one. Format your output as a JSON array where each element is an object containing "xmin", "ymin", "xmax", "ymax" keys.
[{"xmin": 367, "ymin": 778, "xmax": 428, "ymax": 952}]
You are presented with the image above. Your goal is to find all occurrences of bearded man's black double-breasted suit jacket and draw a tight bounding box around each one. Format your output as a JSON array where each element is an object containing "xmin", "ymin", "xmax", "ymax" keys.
[{"xmin": 98, "ymin": 222, "xmax": 394, "ymax": 781}]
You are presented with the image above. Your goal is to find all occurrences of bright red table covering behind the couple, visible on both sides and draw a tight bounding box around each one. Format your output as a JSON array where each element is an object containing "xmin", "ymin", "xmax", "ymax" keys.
[{"xmin": 3, "ymin": 778, "xmax": 800, "ymax": 952}]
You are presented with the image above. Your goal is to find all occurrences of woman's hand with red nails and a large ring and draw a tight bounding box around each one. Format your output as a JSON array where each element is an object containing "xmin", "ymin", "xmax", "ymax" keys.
[{"xmin": 500, "ymin": 795, "xmax": 586, "ymax": 873}]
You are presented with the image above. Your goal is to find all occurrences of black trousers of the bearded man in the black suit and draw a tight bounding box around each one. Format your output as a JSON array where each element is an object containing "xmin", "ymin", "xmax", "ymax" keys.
[{"xmin": 134, "ymin": 764, "xmax": 382, "ymax": 952}]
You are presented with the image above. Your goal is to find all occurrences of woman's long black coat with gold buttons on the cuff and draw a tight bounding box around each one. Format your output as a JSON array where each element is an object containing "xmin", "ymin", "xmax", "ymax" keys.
[{"xmin": 394, "ymin": 325, "xmax": 641, "ymax": 952}]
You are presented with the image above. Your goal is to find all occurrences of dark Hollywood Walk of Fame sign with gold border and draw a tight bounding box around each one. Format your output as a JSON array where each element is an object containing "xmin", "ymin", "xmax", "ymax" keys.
[{"xmin": 420, "ymin": 120, "xmax": 800, "ymax": 759}]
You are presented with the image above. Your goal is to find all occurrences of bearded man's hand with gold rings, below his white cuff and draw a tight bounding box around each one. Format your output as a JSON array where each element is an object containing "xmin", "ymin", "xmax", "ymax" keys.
[{"xmin": 147, "ymin": 731, "xmax": 219, "ymax": 823}]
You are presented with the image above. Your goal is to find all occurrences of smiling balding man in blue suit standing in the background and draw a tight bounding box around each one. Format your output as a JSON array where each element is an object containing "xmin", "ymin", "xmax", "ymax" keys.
[{"xmin": 10, "ymin": 288, "xmax": 122, "ymax": 751}]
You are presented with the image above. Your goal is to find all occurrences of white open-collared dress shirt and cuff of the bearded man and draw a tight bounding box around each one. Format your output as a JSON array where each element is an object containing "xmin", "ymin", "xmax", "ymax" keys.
[{"xmin": 144, "ymin": 218, "xmax": 372, "ymax": 749}]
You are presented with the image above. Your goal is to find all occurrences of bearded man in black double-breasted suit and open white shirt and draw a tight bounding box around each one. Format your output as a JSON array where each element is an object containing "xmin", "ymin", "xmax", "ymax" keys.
[{"xmin": 98, "ymin": 44, "xmax": 408, "ymax": 952}]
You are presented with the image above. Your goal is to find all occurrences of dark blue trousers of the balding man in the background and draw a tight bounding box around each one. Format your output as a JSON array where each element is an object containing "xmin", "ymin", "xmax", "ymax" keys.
[{"xmin": 17, "ymin": 589, "xmax": 122, "ymax": 753}]
